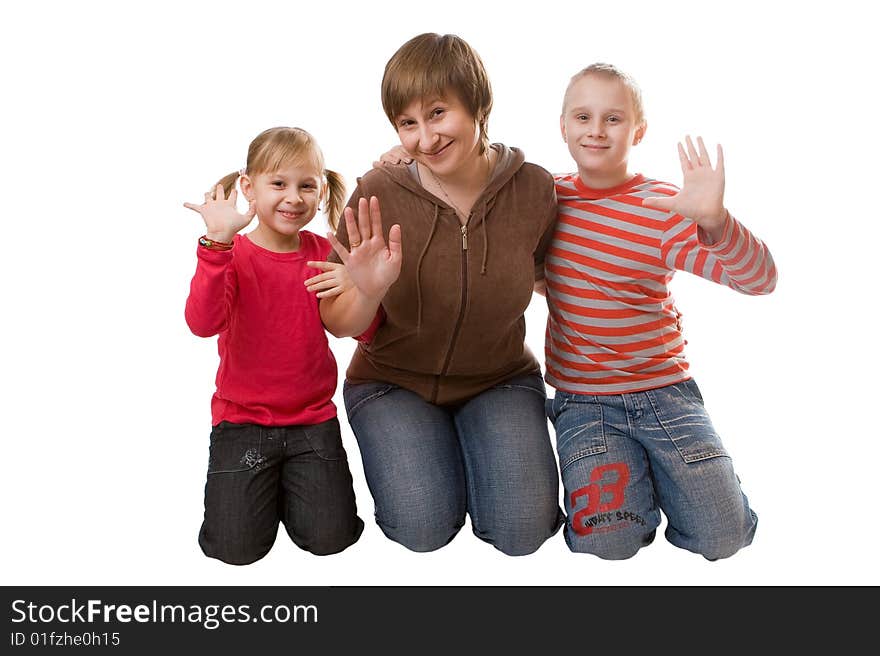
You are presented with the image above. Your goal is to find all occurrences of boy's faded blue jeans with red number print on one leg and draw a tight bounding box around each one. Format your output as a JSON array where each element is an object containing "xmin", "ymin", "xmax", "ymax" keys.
[{"xmin": 547, "ymin": 380, "xmax": 758, "ymax": 560}]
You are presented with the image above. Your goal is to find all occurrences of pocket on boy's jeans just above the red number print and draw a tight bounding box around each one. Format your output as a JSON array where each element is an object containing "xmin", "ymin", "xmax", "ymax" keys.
[{"xmin": 548, "ymin": 393, "xmax": 608, "ymax": 470}]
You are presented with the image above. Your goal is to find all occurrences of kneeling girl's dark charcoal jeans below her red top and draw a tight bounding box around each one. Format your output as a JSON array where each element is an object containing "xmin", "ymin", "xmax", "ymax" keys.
[{"xmin": 199, "ymin": 417, "xmax": 364, "ymax": 565}]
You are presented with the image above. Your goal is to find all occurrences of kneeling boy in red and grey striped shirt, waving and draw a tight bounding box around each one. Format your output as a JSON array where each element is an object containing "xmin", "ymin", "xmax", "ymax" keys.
[{"xmin": 546, "ymin": 64, "xmax": 776, "ymax": 560}]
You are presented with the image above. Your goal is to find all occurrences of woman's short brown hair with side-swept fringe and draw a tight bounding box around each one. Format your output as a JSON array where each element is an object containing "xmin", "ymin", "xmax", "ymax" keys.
[{"xmin": 382, "ymin": 32, "xmax": 492, "ymax": 154}]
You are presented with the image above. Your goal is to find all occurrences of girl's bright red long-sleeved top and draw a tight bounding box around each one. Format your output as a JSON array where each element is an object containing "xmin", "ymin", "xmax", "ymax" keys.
[{"xmin": 186, "ymin": 230, "xmax": 337, "ymax": 426}]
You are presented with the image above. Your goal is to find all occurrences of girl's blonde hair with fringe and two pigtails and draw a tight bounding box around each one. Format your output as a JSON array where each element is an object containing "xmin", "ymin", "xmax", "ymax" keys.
[{"xmin": 211, "ymin": 127, "xmax": 345, "ymax": 231}]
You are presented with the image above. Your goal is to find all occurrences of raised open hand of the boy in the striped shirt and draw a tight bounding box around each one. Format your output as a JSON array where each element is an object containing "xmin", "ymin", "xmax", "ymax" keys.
[{"xmin": 642, "ymin": 137, "xmax": 727, "ymax": 240}]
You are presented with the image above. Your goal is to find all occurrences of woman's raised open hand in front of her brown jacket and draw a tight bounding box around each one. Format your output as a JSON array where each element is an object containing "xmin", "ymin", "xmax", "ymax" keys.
[{"xmin": 327, "ymin": 196, "xmax": 403, "ymax": 301}]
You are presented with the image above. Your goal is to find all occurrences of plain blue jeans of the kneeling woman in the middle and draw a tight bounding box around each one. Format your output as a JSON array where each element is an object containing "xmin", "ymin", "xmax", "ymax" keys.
[{"xmin": 343, "ymin": 375, "xmax": 564, "ymax": 556}]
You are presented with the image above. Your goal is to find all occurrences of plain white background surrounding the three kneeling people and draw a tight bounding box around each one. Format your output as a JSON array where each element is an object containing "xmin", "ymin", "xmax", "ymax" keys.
[{"xmin": 0, "ymin": 0, "xmax": 880, "ymax": 585}]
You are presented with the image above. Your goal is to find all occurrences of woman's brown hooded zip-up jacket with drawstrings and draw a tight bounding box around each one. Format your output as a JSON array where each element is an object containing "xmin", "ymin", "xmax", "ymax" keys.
[{"xmin": 329, "ymin": 144, "xmax": 556, "ymax": 405}]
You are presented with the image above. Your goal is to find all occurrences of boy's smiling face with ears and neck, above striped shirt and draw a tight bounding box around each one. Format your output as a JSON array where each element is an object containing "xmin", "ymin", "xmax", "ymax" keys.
[{"xmin": 559, "ymin": 73, "xmax": 647, "ymax": 188}]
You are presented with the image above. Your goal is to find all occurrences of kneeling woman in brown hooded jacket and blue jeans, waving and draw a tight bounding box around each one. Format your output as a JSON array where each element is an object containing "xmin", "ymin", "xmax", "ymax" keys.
[{"xmin": 321, "ymin": 34, "xmax": 563, "ymax": 555}]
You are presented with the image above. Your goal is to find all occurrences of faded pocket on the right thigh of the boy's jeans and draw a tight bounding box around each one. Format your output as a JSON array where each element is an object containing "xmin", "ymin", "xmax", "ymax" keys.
[{"xmin": 648, "ymin": 380, "xmax": 729, "ymax": 463}]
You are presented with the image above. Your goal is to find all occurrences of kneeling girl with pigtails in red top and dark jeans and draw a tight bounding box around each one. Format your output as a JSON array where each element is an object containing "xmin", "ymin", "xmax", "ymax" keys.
[{"xmin": 184, "ymin": 127, "xmax": 364, "ymax": 565}]
